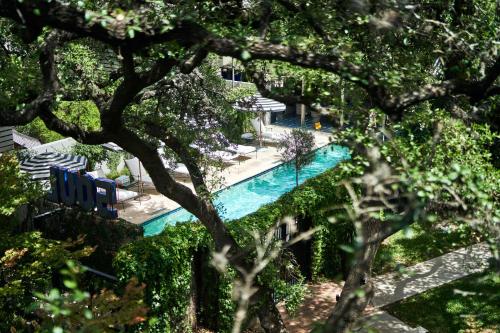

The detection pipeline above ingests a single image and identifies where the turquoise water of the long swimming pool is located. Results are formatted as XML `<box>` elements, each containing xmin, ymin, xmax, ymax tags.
<box><xmin>142</xmin><ymin>145</ymin><xmax>350</xmax><ymax>236</ymax></box>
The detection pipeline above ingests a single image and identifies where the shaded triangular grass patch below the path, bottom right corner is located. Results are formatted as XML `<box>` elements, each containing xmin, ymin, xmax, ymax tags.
<box><xmin>385</xmin><ymin>273</ymin><xmax>500</xmax><ymax>333</ymax></box>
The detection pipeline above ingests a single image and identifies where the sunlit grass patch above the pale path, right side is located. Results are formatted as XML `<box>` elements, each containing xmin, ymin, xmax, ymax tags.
<box><xmin>373</xmin><ymin>225</ymin><xmax>479</xmax><ymax>275</ymax></box>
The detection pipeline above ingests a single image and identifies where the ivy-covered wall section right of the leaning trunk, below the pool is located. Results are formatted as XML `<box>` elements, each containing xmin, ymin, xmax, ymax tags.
<box><xmin>231</xmin><ymin>164</ymin><xmax>356</xmax><ymax>280</ymax></box>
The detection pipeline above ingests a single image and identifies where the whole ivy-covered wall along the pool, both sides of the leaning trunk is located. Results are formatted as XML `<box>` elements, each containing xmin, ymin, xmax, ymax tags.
<box><xmin>113</xmin><ymin>162</ymin><xmax>354</xmax><ymax>333</ymax></box>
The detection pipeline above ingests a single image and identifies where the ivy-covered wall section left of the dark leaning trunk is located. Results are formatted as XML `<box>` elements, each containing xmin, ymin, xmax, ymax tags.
<box><xmin>113</xmin><ymin>223</ymin><xmax>234</xmax><ymax>333</ymax></box>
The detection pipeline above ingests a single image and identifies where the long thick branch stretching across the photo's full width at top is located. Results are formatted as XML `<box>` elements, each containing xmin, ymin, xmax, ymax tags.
<box><xmin>0</xmin><ymin>0</ymin><xmax>498</xmax><ymax>125</ymax></box>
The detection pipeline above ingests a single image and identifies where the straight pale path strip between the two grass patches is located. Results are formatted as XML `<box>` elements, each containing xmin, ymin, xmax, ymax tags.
<box><xmin>372</xmin><ymin>242</ymin><xmax>491</xmax><ymax>308</ymax></box>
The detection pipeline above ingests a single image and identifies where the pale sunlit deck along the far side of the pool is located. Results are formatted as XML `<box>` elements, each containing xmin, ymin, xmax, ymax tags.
<box><xmin>116</xmin><ymin>126</ymin><xmax>331</xmax><ymax>224</ymax></box>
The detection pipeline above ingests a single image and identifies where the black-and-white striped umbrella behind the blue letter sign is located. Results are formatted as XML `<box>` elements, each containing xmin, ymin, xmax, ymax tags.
<box><xmin>20</xmin><ymin>152</ymin><xmax>87</xmax><ymax>179</ymax></box>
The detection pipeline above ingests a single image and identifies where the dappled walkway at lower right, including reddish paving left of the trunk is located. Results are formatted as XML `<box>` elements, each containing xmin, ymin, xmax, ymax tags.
<box><xmin>280</xmin><ymin>243</ymin><xmax>491</xmax><ymax>333</ymax></box>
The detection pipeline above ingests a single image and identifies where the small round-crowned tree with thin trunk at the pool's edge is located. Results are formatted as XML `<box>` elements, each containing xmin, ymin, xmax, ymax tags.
<box><xmin>278</xmin><ymin>129</ymin><xmax>314</xmax><ymax>186</ymax></box>
